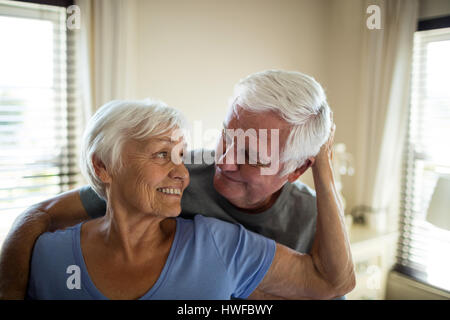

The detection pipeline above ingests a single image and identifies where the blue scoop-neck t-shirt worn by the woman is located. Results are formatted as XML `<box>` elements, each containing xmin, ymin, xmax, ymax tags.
<box><xmin>27</xmin><ymin>215</ymin><xmax>275</xmax><ymax>300</ymax></box>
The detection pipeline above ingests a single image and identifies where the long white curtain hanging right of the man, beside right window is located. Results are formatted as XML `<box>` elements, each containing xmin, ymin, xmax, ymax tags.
<box><xmin>355</xmin><ymin>0</ymin><xmax>418</xmax><ymax>231</ymax></box>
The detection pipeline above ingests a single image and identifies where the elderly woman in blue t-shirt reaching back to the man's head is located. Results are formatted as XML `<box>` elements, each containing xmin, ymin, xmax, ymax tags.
<box><xmin>28</xmin><ymin>101</ymin><xmax>354</xmax><ymax>299</ymax></box>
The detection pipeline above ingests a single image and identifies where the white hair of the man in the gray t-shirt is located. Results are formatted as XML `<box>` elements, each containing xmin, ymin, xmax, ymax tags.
<box><xmin>230</xmin><ymin>70</ymin><xmax>331</xmax><ymax>176</ymax></box>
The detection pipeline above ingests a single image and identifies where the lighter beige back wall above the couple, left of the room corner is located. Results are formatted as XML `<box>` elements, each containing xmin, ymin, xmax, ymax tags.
<box><xmin>138</xmin><ymin>0</ymin><xmax>328</xmax><ymax>146</ymax></box>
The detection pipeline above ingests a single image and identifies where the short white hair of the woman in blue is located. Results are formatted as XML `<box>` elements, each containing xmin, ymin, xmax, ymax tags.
<box><xmin>80</xmin><ymin>99</ymin><xmax>187</xmax><ymax>198</ymax></box>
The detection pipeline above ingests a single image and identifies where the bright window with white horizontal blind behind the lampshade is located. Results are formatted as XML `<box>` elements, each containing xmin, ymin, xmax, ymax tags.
<box><xmin>396</xmin><ymin>28</ymin><xmax>450</xmax><ymax>291</ymax></box>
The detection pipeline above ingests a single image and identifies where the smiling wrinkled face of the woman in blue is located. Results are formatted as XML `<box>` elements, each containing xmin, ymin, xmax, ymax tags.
<box><xmin>111</xmin><ymin>131</ymin><xmax>189</xmax><ymax>217</ymax></box>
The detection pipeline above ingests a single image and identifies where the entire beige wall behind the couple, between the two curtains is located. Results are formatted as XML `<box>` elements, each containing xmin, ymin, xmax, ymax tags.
<box><xmin>133</xmin><ymin>0</ymin><xmax>365</xmax><ymax>207</ymax></box>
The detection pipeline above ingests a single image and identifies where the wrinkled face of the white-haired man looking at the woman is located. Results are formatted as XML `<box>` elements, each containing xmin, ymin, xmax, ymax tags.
<box><xmin>214</xmin><ymin>106</ymin><xmax>289</xmax><ymax>212</ymax></box>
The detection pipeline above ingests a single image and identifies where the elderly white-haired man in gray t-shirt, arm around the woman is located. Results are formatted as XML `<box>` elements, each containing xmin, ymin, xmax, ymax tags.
<box><xmin>0</xmin><ymin>70</ymin><xmax>348</xmax><ymax>298</ymax></box>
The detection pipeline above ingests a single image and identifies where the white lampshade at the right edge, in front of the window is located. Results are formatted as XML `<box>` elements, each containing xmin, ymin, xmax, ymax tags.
<box><xmin>426</xmin><ymin>176</ymin><xmax>450</xmax><ymax>230</ymax></box>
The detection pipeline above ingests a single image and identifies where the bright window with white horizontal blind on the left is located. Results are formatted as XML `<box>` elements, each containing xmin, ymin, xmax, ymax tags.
<box><xmin>0</xmin><ymin>1</ymin><xmax>79</xmax><ymax>235</ymax></box>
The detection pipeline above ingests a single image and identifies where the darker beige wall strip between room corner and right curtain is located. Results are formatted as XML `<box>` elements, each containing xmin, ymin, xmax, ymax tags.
<box><xmin>284</xmin><ymin>0</ymin><xmax>367</xmax><ymax>211</ymax></box>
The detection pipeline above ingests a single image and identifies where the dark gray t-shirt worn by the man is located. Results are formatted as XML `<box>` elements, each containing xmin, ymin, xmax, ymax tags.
<box><xmin>80</xmin><ymin>151</ymin><xmax>317</xmax><ymax>253</ymax></box>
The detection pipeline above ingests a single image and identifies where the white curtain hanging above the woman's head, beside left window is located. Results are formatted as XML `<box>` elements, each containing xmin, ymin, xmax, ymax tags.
<box><xmin>75</xmin><ymin>0</ymin><xmax>138</xmax><ymax>118</ymax></box>
